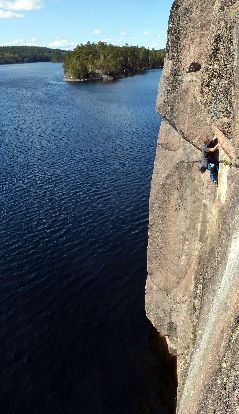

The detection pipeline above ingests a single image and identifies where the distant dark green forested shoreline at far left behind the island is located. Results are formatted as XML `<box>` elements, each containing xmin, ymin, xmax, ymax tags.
<box><xmin>0</xmin><ymin>46</ymin><xmax>67</xmax><ymax>65</ymax></box>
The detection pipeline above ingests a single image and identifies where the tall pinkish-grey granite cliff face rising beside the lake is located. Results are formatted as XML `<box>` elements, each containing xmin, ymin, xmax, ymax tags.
<box><xmin>146</xmin><ymin>0</ymin><xmax>239</xmax><ymax>414</ymax></box>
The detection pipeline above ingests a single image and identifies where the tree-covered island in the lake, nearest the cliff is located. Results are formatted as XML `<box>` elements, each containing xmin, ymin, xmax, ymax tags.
<box><xmin>64</xmin><ymin>42</ymin><xmax>165</xmax><ymax>82</ymax></box>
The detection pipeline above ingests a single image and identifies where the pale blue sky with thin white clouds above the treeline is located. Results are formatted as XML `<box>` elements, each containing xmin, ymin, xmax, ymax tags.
<box><xmin>0</xmin><ymin>0</ymin><xmax>173</xmax><ymax>49</ymax></box>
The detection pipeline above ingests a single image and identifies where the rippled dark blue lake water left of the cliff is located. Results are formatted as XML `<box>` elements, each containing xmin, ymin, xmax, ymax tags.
<box><xmin>0</xmin><ymin>63</ymin><xmax>161</xmax><ymax>414</ymax></box>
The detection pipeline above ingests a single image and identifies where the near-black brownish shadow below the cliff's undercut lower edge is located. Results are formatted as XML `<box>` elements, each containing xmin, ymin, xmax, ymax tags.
<box><xmin>138</xmin><ymin>322</ymin><xmax>178</xmax><ymax>414</ymax></box>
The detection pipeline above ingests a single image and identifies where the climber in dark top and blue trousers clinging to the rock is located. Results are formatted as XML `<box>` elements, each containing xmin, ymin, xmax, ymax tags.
<box><xmin>199</xmin><ymin>138</ymin><xmax>219</xmax><ymax>185</ymax></box>
